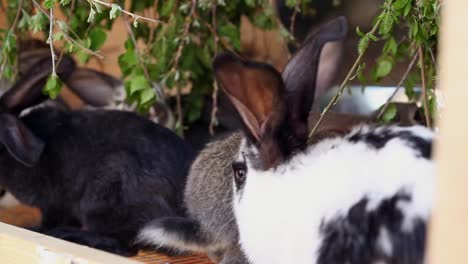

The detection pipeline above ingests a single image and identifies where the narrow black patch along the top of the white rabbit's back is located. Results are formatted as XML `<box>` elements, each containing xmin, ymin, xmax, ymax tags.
<box><xmin>348</xmin><ymin>128</ymin><xmax>432</xmax><ymax>159</ymax></box>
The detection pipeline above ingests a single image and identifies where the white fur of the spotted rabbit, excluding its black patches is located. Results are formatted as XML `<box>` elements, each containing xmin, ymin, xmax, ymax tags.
<box><xmin>234</xmin><ymin>127</ymin><xmax>435</xmax><ymax>264</ymax></box>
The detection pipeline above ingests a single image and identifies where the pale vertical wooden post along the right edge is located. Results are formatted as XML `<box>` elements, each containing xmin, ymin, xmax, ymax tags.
<box><xmin>428</xmin><ymin>0</ymin><xmax>468</xmax><ymax>264</ymax></box>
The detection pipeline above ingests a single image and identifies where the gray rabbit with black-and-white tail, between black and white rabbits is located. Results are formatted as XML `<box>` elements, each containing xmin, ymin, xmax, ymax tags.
<box><xmin>138</xmin><ymin>132</ymin><xmax>248</xmax><ymax>264</ymax></box>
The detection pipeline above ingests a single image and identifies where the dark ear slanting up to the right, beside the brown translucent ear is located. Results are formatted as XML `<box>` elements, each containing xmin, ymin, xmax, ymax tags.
<box><xmin>282</xmin><ymin>17</ymin><xmax>348</xmax><ymax>137</ymax></box>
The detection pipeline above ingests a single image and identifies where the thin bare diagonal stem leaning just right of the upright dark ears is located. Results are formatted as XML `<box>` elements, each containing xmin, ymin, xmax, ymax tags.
<box><xmin>307</xmin><ymin>20</ymin><xmax>380</xmax><ymax>144</ymax></box>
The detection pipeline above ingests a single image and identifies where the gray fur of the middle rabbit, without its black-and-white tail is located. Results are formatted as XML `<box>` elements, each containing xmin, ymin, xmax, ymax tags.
<box><xmin>184</xmin><ymin>132</ymin><xmax>248</xmax><ymax>264</ymax></box>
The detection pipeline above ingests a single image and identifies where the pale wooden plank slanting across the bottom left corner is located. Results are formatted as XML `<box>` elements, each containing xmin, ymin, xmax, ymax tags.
<box><xmin>0</xmin><ymin>223</ymin><xmax>140</xmax><ymax>264</ymax></box>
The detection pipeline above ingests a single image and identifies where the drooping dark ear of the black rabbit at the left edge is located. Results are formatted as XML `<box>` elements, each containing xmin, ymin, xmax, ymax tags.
<box><xmin>0</xmin><ymin>114</ymin><xmax>45</xmax><ymax>167</ymax></box>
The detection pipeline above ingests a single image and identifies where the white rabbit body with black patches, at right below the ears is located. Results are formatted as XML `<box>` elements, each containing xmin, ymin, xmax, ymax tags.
<box><xmin>234</xmin><ymin>126</ymin><xmax>435</xmax><ymax>264</ymax></box>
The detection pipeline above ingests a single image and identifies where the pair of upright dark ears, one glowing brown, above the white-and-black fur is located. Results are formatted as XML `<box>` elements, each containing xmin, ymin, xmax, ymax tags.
<box><xmin>213</xmin><ymin>17</ymin><xmax>347</xmax><ymax>169</ymax></box>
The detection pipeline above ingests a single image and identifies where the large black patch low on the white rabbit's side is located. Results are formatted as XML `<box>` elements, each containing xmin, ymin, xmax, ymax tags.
<box><xmin>317</xmin><ymin>192</ymin><xmax>426</xmax><ymax>264</ymax></box>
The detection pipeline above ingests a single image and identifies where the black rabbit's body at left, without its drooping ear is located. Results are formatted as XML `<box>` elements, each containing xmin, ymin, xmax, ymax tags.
<box><xmin>0</xmin><ymin>108</ymin><xmax>193</xmax><ymax>255</ymax></box>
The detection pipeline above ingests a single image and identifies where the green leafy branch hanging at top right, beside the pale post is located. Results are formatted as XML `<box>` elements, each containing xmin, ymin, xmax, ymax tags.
<box><xmin>309</xmin><ymin>0</ymin><xmax>440</xmax><ymax>142</ymax></box>
